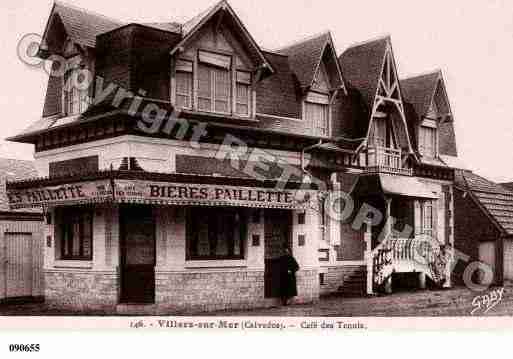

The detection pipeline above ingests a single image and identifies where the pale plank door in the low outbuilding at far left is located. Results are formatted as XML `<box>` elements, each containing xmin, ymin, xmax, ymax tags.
<box><xmin>4</xmin><ymin>233</ymin><xmax>32</xmax><ymax>298</ymax></box>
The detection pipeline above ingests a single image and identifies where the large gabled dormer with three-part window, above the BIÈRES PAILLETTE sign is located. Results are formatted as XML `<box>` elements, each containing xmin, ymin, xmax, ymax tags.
<box><xmin>171</xmin><ymin>1</ymin><xmax>273</xmax><ymax>118</ymax></box>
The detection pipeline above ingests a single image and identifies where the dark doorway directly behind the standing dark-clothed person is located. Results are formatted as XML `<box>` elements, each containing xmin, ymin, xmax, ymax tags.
<box><xmin>264</xmin><ymin>209</ymin><xmax>292</xmax><ymax>298</ymax></box>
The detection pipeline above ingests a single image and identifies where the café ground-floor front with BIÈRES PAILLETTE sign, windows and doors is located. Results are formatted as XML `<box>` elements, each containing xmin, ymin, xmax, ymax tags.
<box><xmin>8</xmin><ymin>171</ymin><xmax>319</xmax><ymax>310</ymax></box>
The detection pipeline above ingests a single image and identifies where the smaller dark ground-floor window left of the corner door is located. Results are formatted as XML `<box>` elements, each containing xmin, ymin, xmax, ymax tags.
<box><xmin>57</xmin><ymin>209</ymin><xmax>93</xmax><ymax>260</ymax></box>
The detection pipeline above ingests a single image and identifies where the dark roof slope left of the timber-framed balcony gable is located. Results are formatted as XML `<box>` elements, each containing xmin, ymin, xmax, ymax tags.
<box><xmin>339</xmin><ymin>36</ymin><xmax>390</xmax><ymax>110</ymax></box>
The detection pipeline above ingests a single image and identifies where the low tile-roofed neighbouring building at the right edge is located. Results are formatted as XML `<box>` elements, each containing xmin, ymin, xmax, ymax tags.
<box><xmin>454</xmin><ymin>171</ymin><xmax>513</xmax><ymax>285</ymax></box>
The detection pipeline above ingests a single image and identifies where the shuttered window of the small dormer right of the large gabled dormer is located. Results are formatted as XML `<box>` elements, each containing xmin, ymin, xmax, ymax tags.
<box><xmin>304</xmin><ymin>92</ymin><xmax>330</xmax><ymax>136</ymax></box>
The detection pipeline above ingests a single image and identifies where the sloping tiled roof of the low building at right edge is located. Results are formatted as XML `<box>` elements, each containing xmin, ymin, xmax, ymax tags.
<box><xmin>455</xmin><ymin>171</ymin><xmax>513</xmax><ymax>235</ymax></box>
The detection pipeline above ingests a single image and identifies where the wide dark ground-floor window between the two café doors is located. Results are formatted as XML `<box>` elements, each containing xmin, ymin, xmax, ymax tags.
<box><xmin>186</xmin><ymin>207</ymin><xmax>247</xmax><ymax>260</ymax></box>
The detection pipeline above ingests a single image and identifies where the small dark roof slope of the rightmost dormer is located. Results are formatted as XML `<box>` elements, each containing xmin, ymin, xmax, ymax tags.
<box><xmin>400</xmin><ymin>70</ymin><xmax>440</xmax><ymax>120</ymax></box>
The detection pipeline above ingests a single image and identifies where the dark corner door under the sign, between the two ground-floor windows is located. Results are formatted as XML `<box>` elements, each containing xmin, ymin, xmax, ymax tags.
<box><xmin>120</xmin><ymin>206</ymin><xmax>156</xmax><ymax>303</ymax></box>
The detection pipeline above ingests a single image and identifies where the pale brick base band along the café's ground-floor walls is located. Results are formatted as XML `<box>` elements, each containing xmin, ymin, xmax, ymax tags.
<box><xmin>45</xmin><ymin>269</ymin><xmax>319</xmax><ymax>314</ymax></box>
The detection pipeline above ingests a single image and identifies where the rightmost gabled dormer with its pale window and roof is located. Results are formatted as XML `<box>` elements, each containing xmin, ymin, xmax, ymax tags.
<box><xmin>401</xmin><ymin>70</ymin><xmax>453</xmax><ymax>160</ymax></box>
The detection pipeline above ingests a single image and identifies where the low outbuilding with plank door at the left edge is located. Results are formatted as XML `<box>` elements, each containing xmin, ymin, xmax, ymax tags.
<box><xmin>0</xmin><ymin>158</ymin><xmax>44</xmax><ymax>303</ymax></box>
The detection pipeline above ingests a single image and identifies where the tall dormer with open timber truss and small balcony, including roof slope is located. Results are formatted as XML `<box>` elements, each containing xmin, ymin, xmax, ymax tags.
<box><xmin>340</xmin><ymin>36</ymin><xmax>413</xmax><ymax>174</ymax></box>
